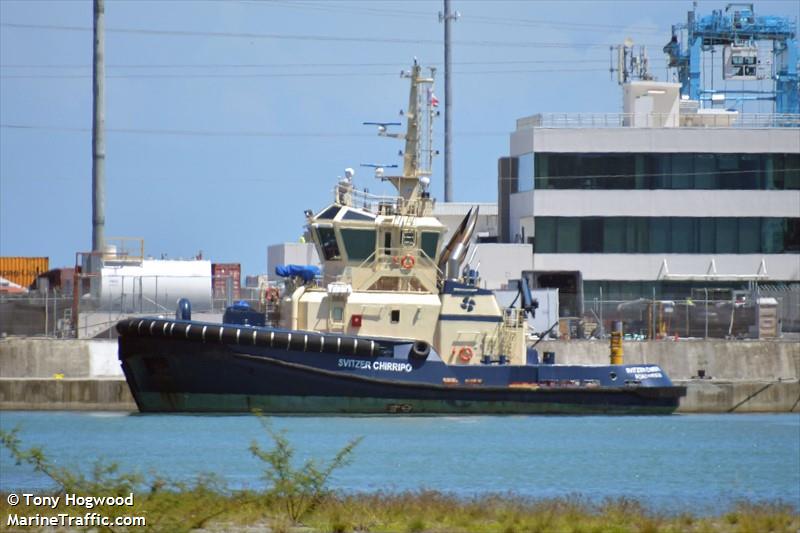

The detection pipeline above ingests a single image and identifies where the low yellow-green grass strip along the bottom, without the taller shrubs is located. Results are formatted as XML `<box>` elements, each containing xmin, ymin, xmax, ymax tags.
<box><xmin>0</xmin><ymin>485</ymin><xmax>800</xmax><ymax>533</ymax></box>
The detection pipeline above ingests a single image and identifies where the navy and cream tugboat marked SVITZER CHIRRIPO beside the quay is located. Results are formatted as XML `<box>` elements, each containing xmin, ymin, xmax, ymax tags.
<box><xmin>117</xmin><ymin>62</ymin><xmax>686</xmax><ymax>414</ymax></box>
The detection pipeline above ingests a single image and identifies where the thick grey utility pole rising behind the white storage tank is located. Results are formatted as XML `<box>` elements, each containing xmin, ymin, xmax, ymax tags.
<box><xmin>90</xmin><ymin>0</ymin><xmax>106</xmax><ymax>260</ymax></box>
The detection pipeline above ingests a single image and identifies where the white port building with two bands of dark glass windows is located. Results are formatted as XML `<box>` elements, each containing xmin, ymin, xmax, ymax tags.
<box><xmin>498</xmin><ymin>81</ymin><xmax>800</xmax><ymax>313</ymax></box>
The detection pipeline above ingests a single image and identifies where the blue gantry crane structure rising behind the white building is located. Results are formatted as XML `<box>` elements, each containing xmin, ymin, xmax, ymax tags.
<box><xmin>664</xmin><ymin>3</ymin><xmax>800</xmax><ymax>114</ymax></box>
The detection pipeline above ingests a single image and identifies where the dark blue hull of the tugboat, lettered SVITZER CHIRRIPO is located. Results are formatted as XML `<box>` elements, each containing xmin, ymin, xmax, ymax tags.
<box><xmin>118</xmin><ymin>319</ymin><xmax>685</xmax><ymax>414</ymax></box>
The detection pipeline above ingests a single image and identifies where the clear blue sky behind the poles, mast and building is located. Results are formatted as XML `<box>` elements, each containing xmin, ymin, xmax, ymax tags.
<box><xmin>0</xmin><ymin>0</ymin><xmax>800</xmax><ymax>274</ymax></box>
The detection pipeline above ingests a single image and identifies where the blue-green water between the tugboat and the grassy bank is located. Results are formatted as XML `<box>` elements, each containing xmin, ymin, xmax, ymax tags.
<box><xmin>0</xmin><ymin>412</ymin><xmax>800</xmax><ymax>514</ymax></box>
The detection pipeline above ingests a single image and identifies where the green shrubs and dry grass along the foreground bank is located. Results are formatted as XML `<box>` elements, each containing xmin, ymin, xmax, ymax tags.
<box><xmin>0</xmin><ymin>417</ymin><xmax>800</xmax><ymax>533</ymax></box>
